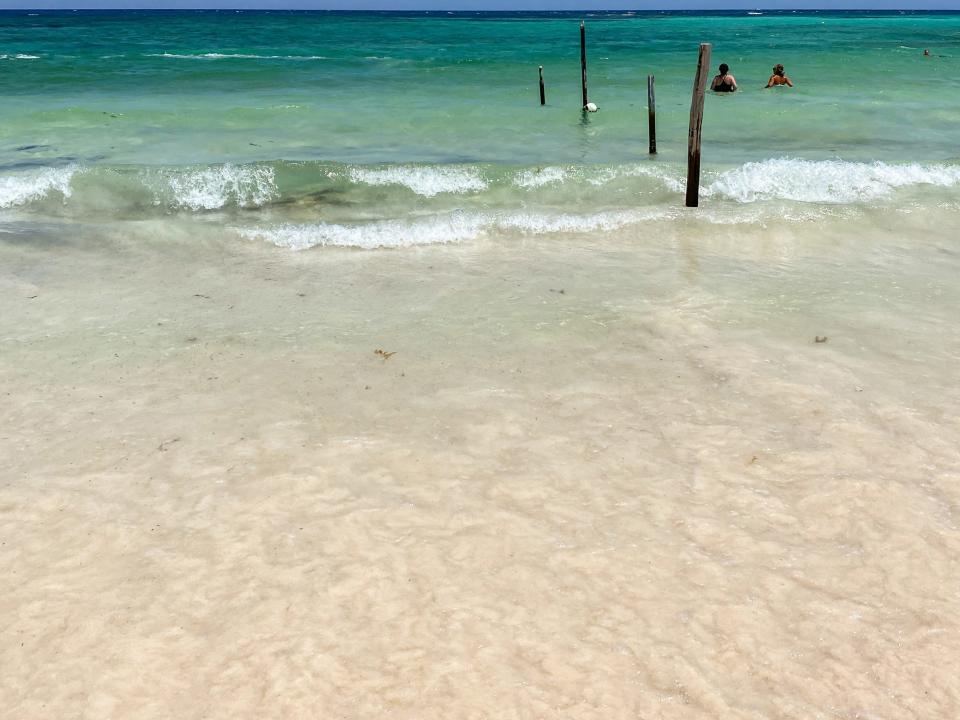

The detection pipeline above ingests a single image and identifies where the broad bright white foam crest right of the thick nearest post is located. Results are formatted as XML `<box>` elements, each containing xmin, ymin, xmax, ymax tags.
<box><xmin>704</xmin><ymin>158</ymin><xmax>960</xmax><ymax>204</ymax></box>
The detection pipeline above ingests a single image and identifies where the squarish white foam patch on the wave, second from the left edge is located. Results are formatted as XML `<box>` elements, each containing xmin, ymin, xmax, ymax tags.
<box><xmin>154</xmin><ymin>165</ymin><xmax>279</xmax><ymax>210</ymax></box>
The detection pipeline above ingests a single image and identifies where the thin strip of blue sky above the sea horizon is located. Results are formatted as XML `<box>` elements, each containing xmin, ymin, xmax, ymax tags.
<box><xmin>0</xmin><ymin>0</ymin><xmax>960</xmax><ymax>10</ymax></box>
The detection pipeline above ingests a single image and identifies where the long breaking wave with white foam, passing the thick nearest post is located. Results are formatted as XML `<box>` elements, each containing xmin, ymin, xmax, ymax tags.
<box><xmin>0</xmin><ymin>158</ymin><xmax>960</xmax><ymax>229</ymax></box>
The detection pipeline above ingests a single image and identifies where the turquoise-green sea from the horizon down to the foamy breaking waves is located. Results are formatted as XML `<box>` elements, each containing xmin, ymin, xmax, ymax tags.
<box><xmin>0</xmin><ymin>11</ymin><xmax>960</xmax><ymax>246</ymax></box>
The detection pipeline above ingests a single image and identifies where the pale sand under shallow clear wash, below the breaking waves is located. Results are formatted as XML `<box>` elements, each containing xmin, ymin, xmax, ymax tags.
<box><xmin>0</xmin><ymin>211</ymin><xmax>960</xmax><ymax>720</ymax></box>
